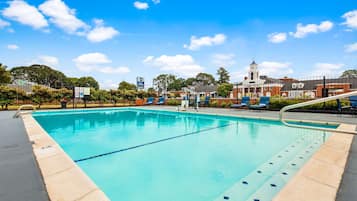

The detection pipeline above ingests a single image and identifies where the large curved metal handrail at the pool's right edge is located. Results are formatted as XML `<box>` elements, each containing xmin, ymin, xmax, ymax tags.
<box><xmin>279</xmin><ymin>91</ymin><xmax>357</xmax><ymax>135</ymax></box>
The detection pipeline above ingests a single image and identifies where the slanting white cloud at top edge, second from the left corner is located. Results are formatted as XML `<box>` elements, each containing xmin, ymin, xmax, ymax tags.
<box><xmin>39</xmin><ymin>0</ymin><xmax>88</xmax><ymax>35</ymax></box>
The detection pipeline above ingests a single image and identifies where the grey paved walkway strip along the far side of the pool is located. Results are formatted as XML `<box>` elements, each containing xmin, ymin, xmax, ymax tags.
<box><xmin>144</xmin><ymin>106</ymin><xmax>357</xmax><ymax>124</ymax></box>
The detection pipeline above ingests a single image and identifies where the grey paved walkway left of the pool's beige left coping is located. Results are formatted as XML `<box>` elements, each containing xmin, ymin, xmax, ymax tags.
<box><xmin>0</xmin><ymin>111</ymin><xmax>49</xmax><ymax>201</ymax></box>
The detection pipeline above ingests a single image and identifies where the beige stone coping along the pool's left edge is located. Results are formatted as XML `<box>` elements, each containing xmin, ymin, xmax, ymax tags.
<box><xmin>21</xmin><ymin>114</ymin><xmax>110</xmax><ymax>201</ymax></box>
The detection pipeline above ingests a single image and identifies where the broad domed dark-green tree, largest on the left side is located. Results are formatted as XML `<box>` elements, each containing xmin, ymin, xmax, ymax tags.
<box><xmin>10</xmin><ymin>64</ymin><xmax>66</xmax><ymax>89</ymax></box>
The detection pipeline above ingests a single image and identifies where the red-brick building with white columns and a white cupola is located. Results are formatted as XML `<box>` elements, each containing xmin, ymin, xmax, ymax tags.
<box><xmin>231</xmin><ymin>61</ymin><xmax>284</xmax><ymax>98</ymax></box>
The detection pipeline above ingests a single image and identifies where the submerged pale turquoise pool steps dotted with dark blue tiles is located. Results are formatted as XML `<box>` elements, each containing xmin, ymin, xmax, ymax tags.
<box><xmin>215</xmin><ymin>134</ymin><xmax>322</xmax><ymax>201</ymax></box>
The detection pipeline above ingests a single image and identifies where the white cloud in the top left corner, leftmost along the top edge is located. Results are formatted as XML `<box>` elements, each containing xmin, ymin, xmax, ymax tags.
<box><xmin>2</xmin><ymin>0</ymin><xmax>48</xmax><ymax>29</ymax></box>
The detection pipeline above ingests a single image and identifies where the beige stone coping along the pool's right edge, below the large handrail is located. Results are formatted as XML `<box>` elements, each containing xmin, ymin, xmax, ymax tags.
<box><xmin>273</xmin><ymin>124</ymin><xmax>357</xmax><ymax>201</ymax></box>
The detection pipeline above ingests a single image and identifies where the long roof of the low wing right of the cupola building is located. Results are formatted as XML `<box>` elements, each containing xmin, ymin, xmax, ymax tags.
<box><xmin>281</xmin><ymin>78</ymin><xmax>357</xmax><ymax>91</ymax></box>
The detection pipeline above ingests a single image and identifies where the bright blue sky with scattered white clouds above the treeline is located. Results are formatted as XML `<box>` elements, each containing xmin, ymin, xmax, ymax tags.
<box><xmin>0</xmin><ymin>0</ymin><xmax>357</xmax><ymax>88</ymax></box>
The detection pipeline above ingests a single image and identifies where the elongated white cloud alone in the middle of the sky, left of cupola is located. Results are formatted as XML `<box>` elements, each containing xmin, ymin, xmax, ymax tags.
<box><xmin>184</xmin><ymin>34</ymin><xmax>227</xmax><ymax>50</ymax></box>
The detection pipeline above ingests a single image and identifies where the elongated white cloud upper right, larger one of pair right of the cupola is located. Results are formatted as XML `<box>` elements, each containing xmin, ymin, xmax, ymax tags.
<box><xmin>290</xmin><ymin>21</ymin><xmax>333</xmax><ymax>38</ymax></box>
